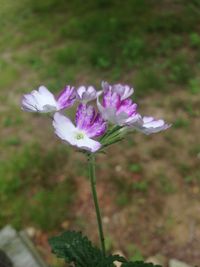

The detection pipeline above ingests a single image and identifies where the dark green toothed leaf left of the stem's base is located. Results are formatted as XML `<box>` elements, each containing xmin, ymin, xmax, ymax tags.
<box><xmin>49</xmin><ymin>231</ymin><xmax>125</xmax><ymax>267</ymax></box>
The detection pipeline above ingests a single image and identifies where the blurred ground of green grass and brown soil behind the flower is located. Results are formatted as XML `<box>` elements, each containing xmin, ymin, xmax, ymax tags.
<box><xmin>0</xmin><ymin>0</ymin><xmax>200</xmax><ymax>266</ymax></box>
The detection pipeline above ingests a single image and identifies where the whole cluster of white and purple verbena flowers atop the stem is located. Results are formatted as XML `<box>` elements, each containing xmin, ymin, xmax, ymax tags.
<box><xmin>21</xmin><ymin>82</ymin><xmax>170</xmax><ymax>152</ymax></box>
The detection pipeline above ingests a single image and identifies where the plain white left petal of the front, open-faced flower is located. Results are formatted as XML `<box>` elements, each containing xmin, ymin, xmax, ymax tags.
<box><xmin>53</xmin><ymin>112</ymin><xmax>76</xmax><ymax>145</ymax></box>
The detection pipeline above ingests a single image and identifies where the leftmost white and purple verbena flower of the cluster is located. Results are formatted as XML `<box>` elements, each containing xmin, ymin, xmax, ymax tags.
<box><xmin>21</xmin><ymin>85</ymin><xmax>76</xmax><ymax>113</ymax></box>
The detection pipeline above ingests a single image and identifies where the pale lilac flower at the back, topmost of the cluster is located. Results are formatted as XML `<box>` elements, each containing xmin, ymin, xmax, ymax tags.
<box><xmin>101</xmin><ymin>82</ymin><xmax>134</xmax><ymax>100</ymax></box>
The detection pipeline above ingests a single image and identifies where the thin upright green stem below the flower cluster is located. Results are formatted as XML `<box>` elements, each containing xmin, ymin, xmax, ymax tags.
<box><xmin>88</xmin><ymin>154</ymin><xmax>106</xmax><ymax>256</ymax></box>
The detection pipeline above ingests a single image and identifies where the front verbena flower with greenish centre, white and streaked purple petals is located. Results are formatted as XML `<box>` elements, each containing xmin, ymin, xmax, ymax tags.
<box><xmin>53</xmin><ymin>104</ymin><xmax>107</xmax><ymax>152</ymax></box>
